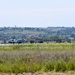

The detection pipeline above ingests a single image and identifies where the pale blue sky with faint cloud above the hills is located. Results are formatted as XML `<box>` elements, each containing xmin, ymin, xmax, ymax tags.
<box><xmin>0</xmin><ymin>0</ymin><xmax>75</xmax><ymax>27</ymax></box>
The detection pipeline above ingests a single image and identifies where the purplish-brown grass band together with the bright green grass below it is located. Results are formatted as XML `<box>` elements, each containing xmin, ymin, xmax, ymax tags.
<box><xmin>0</xmin><ymin>50</ymin><xmax>75</xmax><ymax>73</ymax></box>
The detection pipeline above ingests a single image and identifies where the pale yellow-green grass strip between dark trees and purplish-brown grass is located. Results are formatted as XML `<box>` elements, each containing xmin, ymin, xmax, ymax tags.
<box><xmin>0</xmin><ymin>43</ymin><xmax>75</xmax><ymax>50</ymax></box>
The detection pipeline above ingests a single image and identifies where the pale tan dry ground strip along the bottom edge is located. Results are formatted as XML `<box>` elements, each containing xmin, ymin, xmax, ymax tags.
<box><xmin>0</xmin><ymin>71</ymin><xmax>75</xmax><ymax>75</ymax></box>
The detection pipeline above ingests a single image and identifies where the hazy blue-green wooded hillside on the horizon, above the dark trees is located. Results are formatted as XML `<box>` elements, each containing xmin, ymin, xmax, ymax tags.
<box><xmin>0</xmin><ymin>27</ymin><xmax>75</xmax><ymax>41</ymax></box>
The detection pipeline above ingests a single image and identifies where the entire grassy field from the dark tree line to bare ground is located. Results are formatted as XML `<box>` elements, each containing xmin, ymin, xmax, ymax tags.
<box><xmin>0</xmin><ymin>43</ymin><xmax>75</xmax><ymax>75</ymax></box>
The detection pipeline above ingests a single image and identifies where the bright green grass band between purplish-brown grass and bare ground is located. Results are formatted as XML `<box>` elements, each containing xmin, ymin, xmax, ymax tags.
<box><xmin>0</xmin><ymin>60</ymin><xmax>75</xmax><ymax>73</ymax></box>
